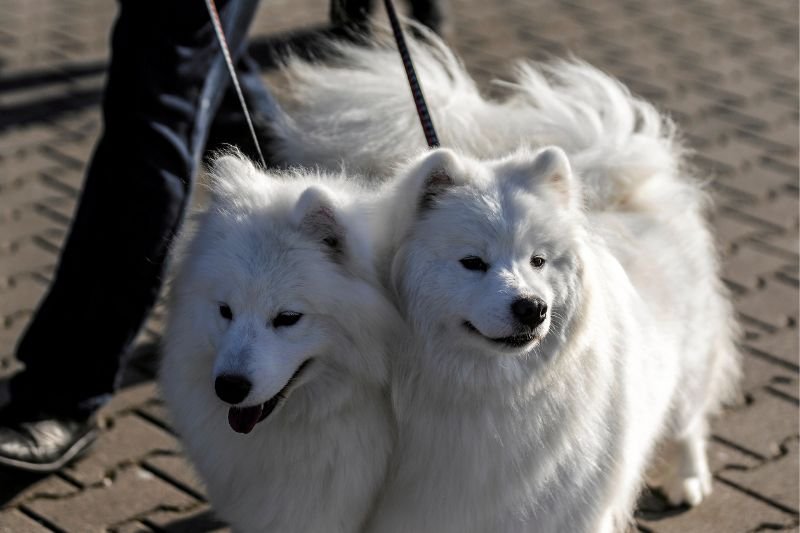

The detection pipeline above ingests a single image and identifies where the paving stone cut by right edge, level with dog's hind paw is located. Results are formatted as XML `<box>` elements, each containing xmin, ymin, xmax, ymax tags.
<box><xmin>719</xmin><ymin>438</ymin><xmax>800</xmax><ymax>513</ymax></box>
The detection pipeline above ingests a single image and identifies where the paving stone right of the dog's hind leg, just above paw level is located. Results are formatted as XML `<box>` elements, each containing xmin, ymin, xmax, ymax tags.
<box><xmin>712</xmin><ymin>391</ymin><xmax>799</xmax><ymax>459</ymax></box>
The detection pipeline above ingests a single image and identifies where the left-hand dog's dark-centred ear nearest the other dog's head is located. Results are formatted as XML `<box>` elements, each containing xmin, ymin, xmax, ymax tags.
<box><xmin>292</xmin><ymin>186</ymin><xmax>345</xmax><ymax>253</ymax></box>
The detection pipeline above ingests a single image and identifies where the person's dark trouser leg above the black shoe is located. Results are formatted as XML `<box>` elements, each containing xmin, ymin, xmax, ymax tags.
<box><xmin>10</xmin><ymin>0</ymin><xmax>271</xmax><ymax>413</ymax></box>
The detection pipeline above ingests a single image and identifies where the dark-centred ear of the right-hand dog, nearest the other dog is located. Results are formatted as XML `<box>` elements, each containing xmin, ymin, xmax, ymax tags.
<box><xmin>409</xmin><ymin>148</ymin><xmax>461</xmax><ymax>211</ymax></box>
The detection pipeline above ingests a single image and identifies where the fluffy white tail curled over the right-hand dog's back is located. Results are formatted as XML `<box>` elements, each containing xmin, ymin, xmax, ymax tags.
<box><xmin>504</xmin><ymin>60</ymin><xmax>698</xmax><ymax>211</ymax></box>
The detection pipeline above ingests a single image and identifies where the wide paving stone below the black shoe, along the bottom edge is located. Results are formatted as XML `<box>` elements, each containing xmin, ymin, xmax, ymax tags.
<box><xmin>26</xmin><ymin>466</ymin><xmax>196</xmax><ymax>533</ymax></box>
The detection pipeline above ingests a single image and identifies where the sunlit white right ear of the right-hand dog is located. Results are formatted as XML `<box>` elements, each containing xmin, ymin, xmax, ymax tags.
<box><xmin>516</xmin><ymin>146</ymin><xmax>580</xmax><ymax>208</ymax></box>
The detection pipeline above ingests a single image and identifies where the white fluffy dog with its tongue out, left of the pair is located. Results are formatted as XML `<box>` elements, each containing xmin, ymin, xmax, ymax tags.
<box><xmin>161</xmin><ymin>156</ymin><xmax>402</xmax><ymax>533</ymax></box>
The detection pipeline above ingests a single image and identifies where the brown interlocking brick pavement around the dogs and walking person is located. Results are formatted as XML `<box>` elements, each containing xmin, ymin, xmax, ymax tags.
<box><xmin>0</xmin><ymin>0</ymin><xmax>800</xmax><ymax>533</ymax></box>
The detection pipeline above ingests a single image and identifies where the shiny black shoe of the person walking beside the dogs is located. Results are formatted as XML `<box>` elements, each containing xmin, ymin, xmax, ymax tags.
<box><xmin>0</xmin><ymin>405</ymin><xmax>98</xmax><ymax>473</ymax></box>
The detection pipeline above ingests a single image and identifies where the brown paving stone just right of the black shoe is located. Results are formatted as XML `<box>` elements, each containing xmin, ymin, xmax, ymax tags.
<box><xmin>64</xmin><ymin>414</ymin><xmax>180</xmax><ymax>486</ymax></box>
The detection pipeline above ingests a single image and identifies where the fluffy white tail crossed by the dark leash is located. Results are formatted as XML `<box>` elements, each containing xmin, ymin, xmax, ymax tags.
<box><xmin>272</xmin><ymin>28</ymin><xmax>494</xmax><ymax>178</ymax></box>
